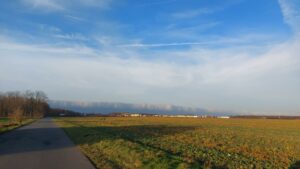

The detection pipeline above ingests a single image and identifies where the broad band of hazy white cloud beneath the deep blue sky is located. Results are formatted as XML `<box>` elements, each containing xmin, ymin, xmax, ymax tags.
<box><xmin>0</xmin><ymin>32</ymin><xmax>300</xmax><ymax>114</ymax></box>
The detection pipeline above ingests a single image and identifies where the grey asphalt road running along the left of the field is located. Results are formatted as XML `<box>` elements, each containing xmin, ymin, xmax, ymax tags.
<box><xmin>0</xmin><ymin>118</ymin><xmax>94</xmax><ymax>169</ymax></box>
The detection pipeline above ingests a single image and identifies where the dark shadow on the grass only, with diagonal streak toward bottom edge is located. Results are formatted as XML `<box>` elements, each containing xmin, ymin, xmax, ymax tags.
<box><xmin>64</xmin><ymin>125</ymin><xmax>226</xmax><ymax>169</ymax></box>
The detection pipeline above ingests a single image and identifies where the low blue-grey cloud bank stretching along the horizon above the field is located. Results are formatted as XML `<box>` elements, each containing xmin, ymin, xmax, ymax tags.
<box><xmin>48</xmin><ymin>100</ymin><xmax>299</xmax><ymax>116</ymax></box>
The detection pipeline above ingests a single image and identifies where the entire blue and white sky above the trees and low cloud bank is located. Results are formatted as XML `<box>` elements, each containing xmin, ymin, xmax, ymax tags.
<box><xmin>0</xmin><ymin>0</ymin><xmax>300</xmax><ymax>115</ymax></box>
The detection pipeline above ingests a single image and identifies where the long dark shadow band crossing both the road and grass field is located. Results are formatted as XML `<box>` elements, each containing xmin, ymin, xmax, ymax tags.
<box><xmin>0</xmin><ymin>121</ymin><xmax>194</xmax><ymax>158</ymax></box>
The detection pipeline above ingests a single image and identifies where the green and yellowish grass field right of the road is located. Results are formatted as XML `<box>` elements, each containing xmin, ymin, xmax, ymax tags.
<box><xmin>56</xmin><ymin>117</ymin><xmax>300</xmax><ymax>169</ymax></box>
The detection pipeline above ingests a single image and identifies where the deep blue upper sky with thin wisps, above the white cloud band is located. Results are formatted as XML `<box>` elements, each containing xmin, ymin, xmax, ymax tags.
<box><xmin>0</xmin><ymin>0</ymin><xmax>291</xmax><ymax>47</ymax></box>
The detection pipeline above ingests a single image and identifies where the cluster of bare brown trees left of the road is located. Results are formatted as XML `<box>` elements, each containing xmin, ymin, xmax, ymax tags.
<box><xmin>0</xmin><ymin>90</ymin><xmax>50</xmax><ymax>118</ymax></box>
